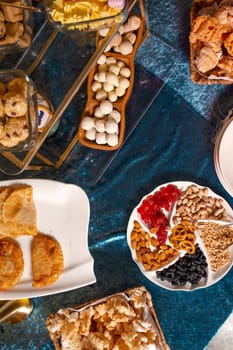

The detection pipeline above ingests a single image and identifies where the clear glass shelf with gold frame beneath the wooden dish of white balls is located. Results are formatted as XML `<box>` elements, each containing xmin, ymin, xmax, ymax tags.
<box><xmin>0</xmin><ymin>0</ymin><xmax>176</xmax><ymax>185</ymax></box>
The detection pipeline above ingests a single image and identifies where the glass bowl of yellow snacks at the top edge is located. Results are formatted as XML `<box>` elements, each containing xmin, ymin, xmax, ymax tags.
<box><xmin>46</xmin><ymin>0</ymin><xmax>128</xmax><ymax>32</ymax></box>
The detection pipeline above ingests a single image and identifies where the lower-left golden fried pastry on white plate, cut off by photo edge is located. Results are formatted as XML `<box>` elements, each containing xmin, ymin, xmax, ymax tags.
<box><xmin>0</xmin><ymin>238</ymin><xmax>24</xmax><ymax>290</ymax></box>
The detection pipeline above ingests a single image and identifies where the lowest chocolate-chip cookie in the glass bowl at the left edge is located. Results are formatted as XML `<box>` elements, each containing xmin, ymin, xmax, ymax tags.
<box><xmin>0</xmin><ymin>117</ymin><xmax>29</xmax><ymax>147</ymax></box>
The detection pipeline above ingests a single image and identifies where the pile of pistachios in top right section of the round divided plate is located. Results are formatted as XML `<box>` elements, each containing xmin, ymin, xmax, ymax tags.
<box><xmin>173</xmin><ymin>185</ymin><xmax>226</xmax><ymax>224</ymax></box>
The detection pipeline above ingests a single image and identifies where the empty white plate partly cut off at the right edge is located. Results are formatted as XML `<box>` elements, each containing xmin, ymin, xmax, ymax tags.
<box><xmin>214</xmin><ymin>118</ymin><xmax>233</xmax><ymax>196</ymax></box>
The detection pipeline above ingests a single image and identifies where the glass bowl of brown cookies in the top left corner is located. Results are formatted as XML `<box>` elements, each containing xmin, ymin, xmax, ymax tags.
<box><xmin>0</xmin><ymin>0</ymin><xmax>33</xmax><ymax>54</ymax></box>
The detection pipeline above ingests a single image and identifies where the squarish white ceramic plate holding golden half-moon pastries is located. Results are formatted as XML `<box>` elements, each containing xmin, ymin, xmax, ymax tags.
<box><xmin>0</xmin><ymin>179</ymin><xmax>96</xmax><ymax>300</ymax></box>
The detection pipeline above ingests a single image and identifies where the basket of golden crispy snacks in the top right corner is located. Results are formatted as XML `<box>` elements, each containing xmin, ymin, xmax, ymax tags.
<box><xmin>189</xmin><ymin>0</ymin><xmax>233</xmax><ymax>84</ymax></box>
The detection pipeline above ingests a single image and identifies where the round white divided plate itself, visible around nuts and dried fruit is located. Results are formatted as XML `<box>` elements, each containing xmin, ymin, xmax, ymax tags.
<box><xmin>127</xmin><ymin>181</ymin><xmax>233</xmax><ymax>291</ymax></box>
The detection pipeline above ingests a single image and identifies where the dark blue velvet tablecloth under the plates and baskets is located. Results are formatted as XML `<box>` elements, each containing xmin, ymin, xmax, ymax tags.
<box><xmin>0</xmin><ymin>0</ymin><xmax>233</xmax><ymax>350</ymax></box>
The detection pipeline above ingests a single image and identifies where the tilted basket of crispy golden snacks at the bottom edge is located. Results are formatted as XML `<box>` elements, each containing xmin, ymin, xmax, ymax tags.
<box><xmin>46</xmin><ymin>287</ymin><xmax>169</xmax><ymax>350</ymax></box>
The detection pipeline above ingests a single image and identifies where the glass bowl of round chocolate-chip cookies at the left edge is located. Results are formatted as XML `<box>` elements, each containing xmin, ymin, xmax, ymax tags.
<box><xmin>0</xmin><ymin>69</ymin><xmax>38</xmax><ymax>152</ymax></box>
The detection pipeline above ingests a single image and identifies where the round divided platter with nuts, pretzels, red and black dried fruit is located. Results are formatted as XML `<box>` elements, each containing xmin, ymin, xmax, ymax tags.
<box><xmin>127</xmin><ymin>181</ymin><xmax>233</xmax><ymax>291</ymax></box>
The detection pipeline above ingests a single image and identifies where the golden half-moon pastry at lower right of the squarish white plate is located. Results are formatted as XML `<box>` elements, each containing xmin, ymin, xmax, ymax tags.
<box><xmin>32</xmin><ymin>233</ymin><xmax>64</xmax><ymax>288</ymax></box>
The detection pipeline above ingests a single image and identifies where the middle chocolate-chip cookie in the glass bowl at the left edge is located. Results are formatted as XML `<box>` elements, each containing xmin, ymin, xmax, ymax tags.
<box><xmin>4</xmin><ymin>92</ymin><xmax>27</xmax><ymax>117</ymax></box>
